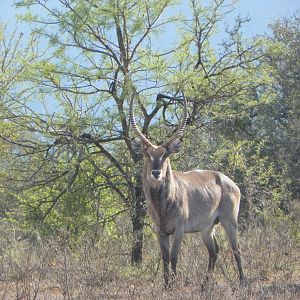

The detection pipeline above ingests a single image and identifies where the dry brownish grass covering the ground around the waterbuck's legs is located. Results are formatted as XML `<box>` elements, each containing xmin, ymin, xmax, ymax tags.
<box><xmin>0</xmin><ymin>219</ymin><xmax>300</xmax><ymax>300</ymax></box>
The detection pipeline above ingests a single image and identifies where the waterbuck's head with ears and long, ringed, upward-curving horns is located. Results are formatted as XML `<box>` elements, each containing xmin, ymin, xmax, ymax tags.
<box><xmin>129</xmin><ymin>98</ymin><xmax>187</xmax><ymax>181</ymax></box>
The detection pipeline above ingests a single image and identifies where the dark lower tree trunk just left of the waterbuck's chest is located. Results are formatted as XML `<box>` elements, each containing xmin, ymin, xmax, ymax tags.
<box><xmin>131</xmin><ymin>176</ymin><xmax>146</xmax><ymax>265</ymax></box>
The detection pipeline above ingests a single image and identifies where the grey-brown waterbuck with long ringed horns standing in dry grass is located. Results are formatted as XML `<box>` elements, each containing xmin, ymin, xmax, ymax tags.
<box><xmin>129</xmin><ymin>98</ymin><xmax>244</xmax><ymax>286</ymax></box>
